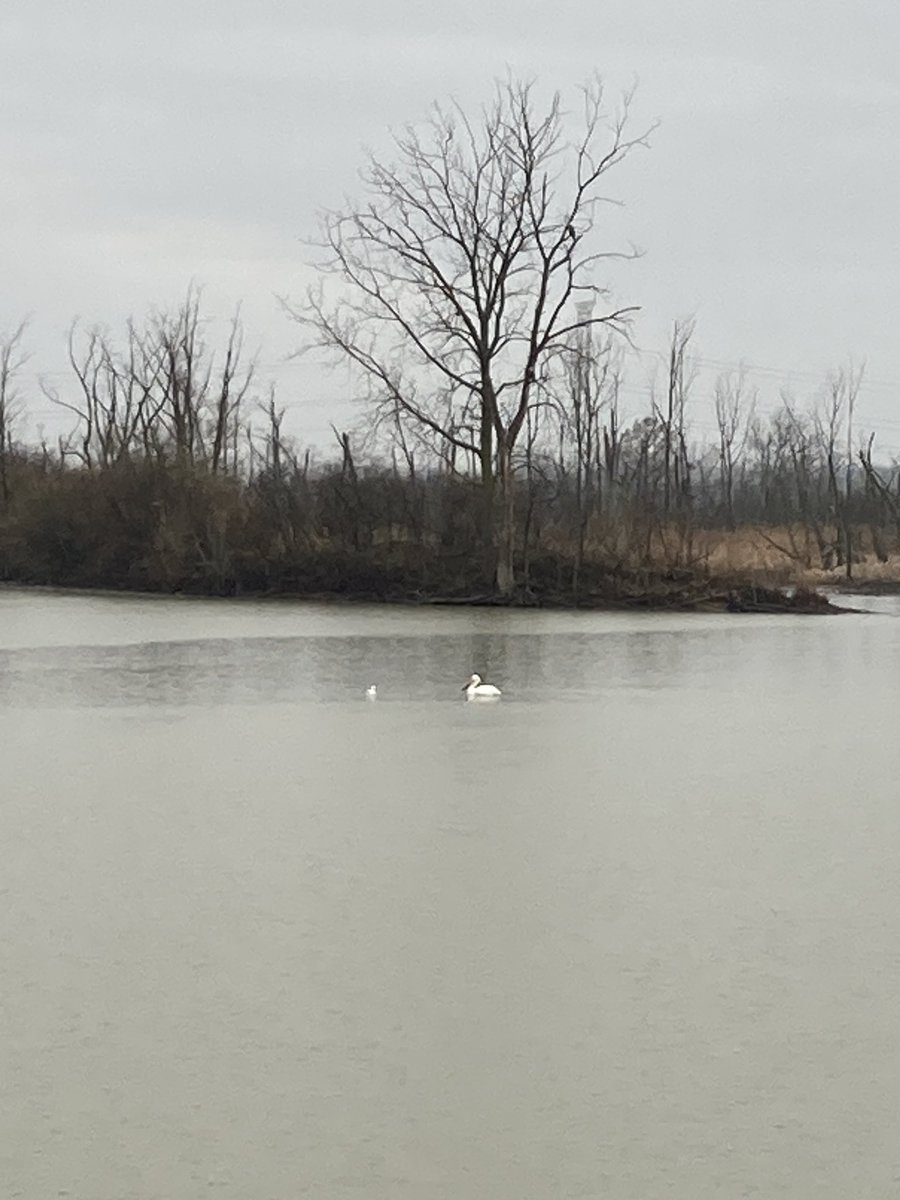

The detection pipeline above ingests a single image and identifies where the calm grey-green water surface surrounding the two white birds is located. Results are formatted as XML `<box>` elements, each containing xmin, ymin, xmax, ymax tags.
<box><xmin>0</xmin><ymin>592</ymin><xmax>900</xmax><ymax>1200</ymax></box>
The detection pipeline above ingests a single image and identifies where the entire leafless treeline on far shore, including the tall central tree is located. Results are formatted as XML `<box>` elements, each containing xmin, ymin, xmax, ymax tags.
<box><xmin>0</xmin><ymin>84</ymin><xmax>900</xmax><ymax>602</ymax></box>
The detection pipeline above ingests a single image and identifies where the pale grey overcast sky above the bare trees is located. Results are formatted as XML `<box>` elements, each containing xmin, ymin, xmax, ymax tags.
<box><xmin>0</xmin><ymin>0</ymin><xmax>900</xmax><ymax>454</ymax></box>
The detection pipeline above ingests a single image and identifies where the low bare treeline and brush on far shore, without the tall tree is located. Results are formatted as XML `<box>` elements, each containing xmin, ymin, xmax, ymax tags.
<box><xmin>0</xmin><ymin>300</ymin><xmax>900</xmax><ymax>601</ymax></box>
